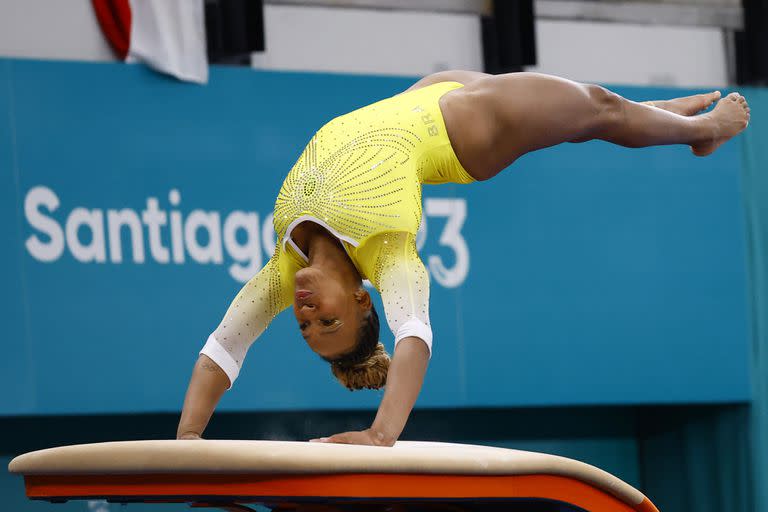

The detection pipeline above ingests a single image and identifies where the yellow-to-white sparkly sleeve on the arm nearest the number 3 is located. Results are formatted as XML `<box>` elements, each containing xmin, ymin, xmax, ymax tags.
<box><xmin>371</xmin><ymin>232</ymin><xmax>432</xmax><ymax>356</ymax></box>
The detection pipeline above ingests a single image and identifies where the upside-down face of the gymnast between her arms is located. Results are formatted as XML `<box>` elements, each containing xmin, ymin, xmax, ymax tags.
<box><xmin>293</xmin><ymin>267</ymin><xmax>365</xmax><ymax>359</ymax></box>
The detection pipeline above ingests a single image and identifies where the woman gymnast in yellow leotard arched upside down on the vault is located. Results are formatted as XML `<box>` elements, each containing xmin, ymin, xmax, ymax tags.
<box><xmin>177</xmin><ymin>71</ymin><xmax>749</xmax><ymax>446</ymax></box>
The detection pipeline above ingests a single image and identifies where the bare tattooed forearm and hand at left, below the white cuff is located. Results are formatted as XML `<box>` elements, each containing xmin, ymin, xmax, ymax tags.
<box><xmin>176</xmin><ymin>354</ymin><xmax>230</xmax><ymax>439</ymax></box>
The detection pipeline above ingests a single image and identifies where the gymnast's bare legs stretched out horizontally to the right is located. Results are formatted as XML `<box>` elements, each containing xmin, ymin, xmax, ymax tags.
<box><xmin>440</xmin><ymin>73</ymin><xmax>749</xmax><ymax>179</ymax></box>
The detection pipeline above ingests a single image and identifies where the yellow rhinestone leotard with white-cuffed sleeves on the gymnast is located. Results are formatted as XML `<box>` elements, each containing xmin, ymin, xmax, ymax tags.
<box><xmin>201</xmin><ymin>82</ymin><xmax>474</xmax><ymax>382</ymax></box>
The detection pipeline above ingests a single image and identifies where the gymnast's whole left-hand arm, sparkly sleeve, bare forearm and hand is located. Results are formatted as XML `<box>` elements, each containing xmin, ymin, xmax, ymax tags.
<box><xmin>176</xmin><ymin>254</ymin><xmax>290</xmax><ymax>439</ymax></box>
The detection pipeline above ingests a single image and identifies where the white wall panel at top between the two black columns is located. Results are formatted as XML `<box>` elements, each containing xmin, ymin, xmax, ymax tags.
<box><xmin>253</xmin><ymin>5</ymin><xmax>483</xmax><ymax>75</ymax></box>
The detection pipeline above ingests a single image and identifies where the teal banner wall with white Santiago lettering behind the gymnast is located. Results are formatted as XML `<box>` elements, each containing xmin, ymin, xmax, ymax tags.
<box><xmin>0</xmin><ymin>60</ymin><xmax>752</xmax><ymax>415</ymax></box>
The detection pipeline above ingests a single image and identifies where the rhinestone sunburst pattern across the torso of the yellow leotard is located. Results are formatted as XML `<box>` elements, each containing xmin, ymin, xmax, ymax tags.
<box><xmin>274</xmin><ymin>128</ymin><xmax>421</xmax><ymax>241</ymax></box>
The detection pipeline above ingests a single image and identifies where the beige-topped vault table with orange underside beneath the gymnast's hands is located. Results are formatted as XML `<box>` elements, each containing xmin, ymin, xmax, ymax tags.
<box><xmin>9</xmin><ymin>440</ymin><xmax>658</xmax><ymax>512</ymax></box>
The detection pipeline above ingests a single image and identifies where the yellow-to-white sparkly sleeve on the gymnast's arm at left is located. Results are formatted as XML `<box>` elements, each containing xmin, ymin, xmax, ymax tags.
<box><xmin>200</xmin><ymin>250</ymin><xmax>291</xmax><ymax>388</ymax></box>
